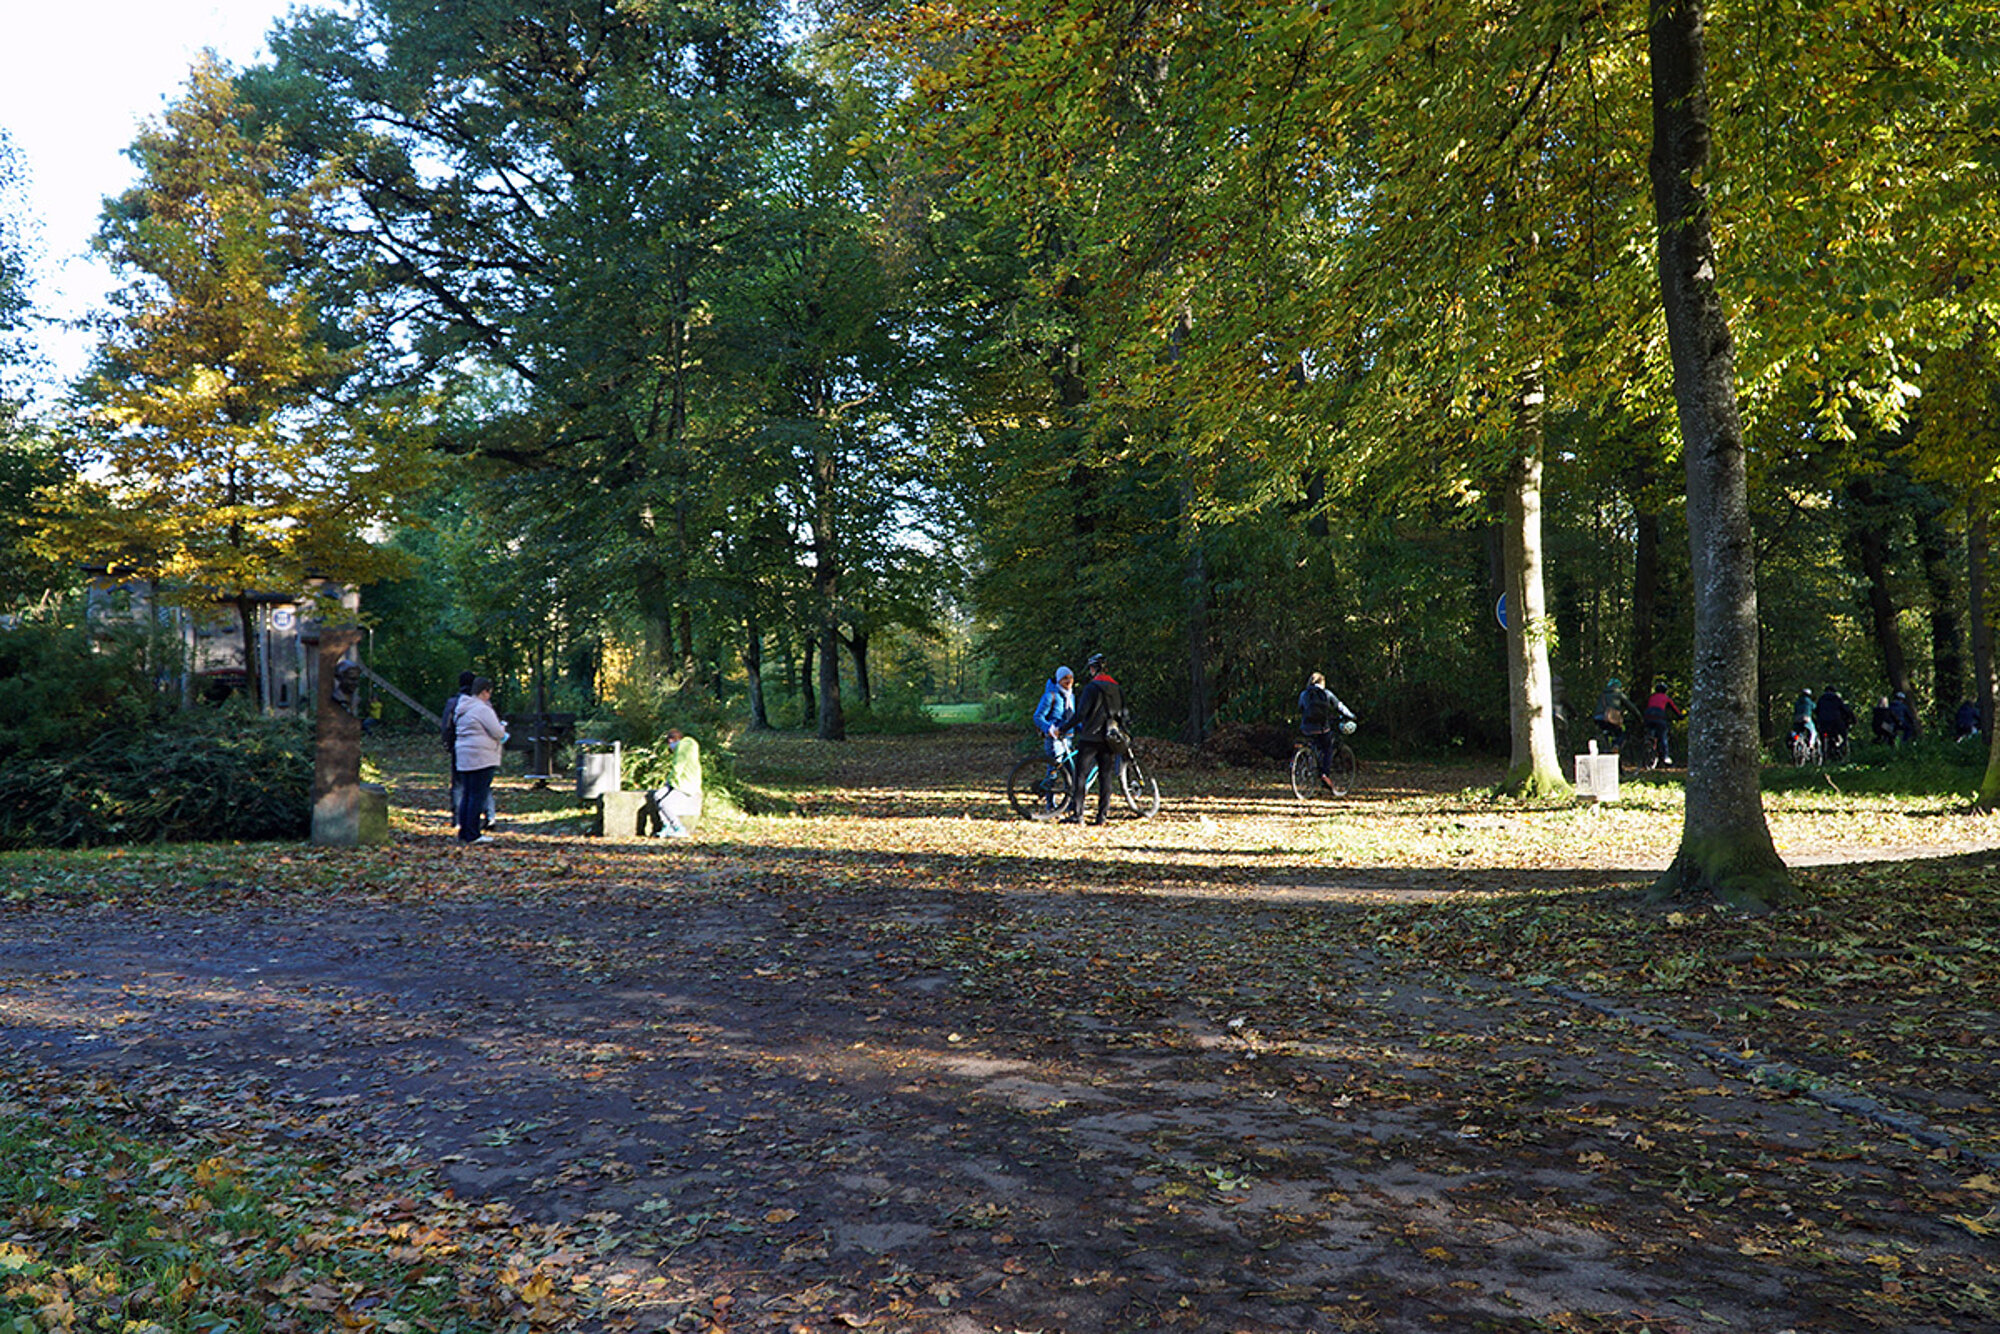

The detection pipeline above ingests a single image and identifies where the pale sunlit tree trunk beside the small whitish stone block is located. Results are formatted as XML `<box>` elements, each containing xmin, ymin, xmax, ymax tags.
<box><xmin>1502</xmin><ymin>372</ymin><xmax>1570</xmax><ymax>798</ymax></box>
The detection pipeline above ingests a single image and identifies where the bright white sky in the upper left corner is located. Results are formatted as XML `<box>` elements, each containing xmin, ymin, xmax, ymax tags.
<box><xmin>0</xmin><ymin>0</ymin><xmax>292</xmax><ymax>396</ymax></box>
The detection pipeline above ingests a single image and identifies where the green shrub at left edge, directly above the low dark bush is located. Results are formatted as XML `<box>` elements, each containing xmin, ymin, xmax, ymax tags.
<box><xmin>0</xmin><ymin>616</ymin><xmax>160</xmax><ymax>764</ymax></box>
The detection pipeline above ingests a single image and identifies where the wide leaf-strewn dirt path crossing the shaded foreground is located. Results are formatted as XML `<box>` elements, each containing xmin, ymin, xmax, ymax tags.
<box><xmin>0</xmin><ymin>744</ymin><xmax>2000</xmax><ymax>1334</ymax></box>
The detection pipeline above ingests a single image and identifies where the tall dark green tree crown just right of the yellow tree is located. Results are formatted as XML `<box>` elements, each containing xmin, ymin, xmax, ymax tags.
<box><xmin>258</xmin><ymin>0</ymin><xmax>806</xmax><ymax>708</ymax></box>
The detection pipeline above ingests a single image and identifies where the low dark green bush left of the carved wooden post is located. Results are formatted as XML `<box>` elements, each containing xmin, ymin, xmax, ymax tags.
<box><xmin>0</xmin><ymin>708</ymin><xmax>312</xmax><ymax>848</ymax></box>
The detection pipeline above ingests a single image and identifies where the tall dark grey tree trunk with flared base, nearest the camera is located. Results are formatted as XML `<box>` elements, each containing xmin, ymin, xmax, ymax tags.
<box><xmin>1648</xmin><ymin>0</ymin><xmax>1792</xmax><ymax>908</ymax></box>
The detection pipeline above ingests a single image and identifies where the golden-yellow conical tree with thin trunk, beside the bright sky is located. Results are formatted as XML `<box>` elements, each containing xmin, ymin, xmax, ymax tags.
<box><xmin>40</xmin><ymin>56</ymin><xmax>428</xmax><ymax>704</ymax></box>
